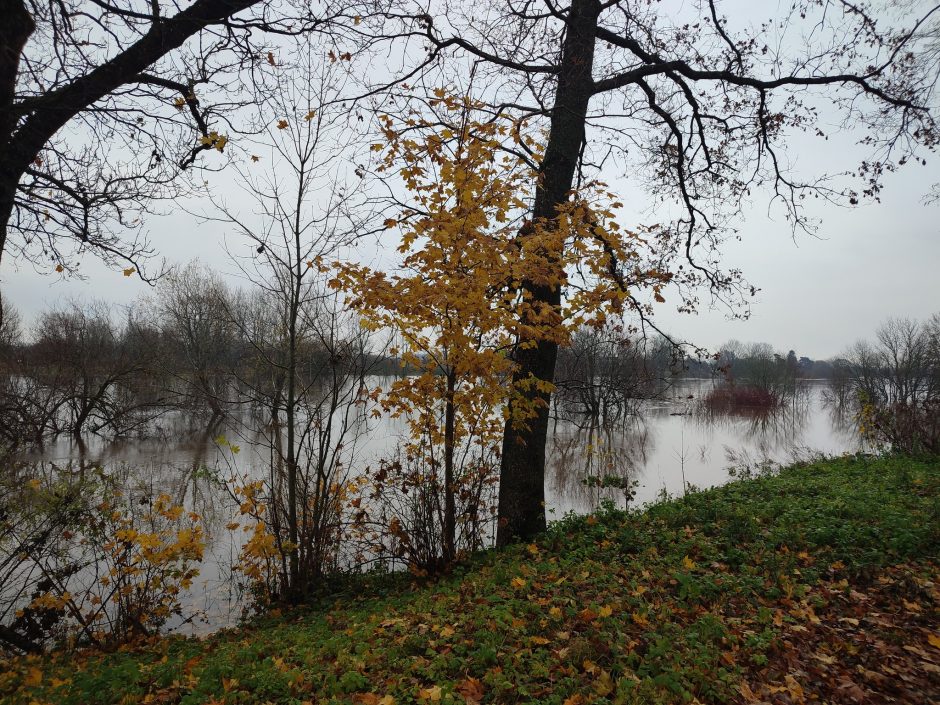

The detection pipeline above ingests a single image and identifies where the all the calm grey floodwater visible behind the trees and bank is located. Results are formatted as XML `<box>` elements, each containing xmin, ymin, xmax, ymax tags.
<box><xmin>9</xmin><ymin>380</ymin><xmax>863</xmax><ymax>633</ymax></box>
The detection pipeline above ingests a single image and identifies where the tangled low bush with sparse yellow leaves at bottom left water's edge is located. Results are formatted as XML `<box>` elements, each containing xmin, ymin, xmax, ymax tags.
<box><xmin>0</xmin><ymin>471</ymin><xmax>205</xmax><ymax>651</ymax></box>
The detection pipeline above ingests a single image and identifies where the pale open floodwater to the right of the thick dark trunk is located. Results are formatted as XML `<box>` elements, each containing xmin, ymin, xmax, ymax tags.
<box><xmin>546</xmin><ymin>380</ymin><xmax>864</xmax><ymax>516</ymax></box>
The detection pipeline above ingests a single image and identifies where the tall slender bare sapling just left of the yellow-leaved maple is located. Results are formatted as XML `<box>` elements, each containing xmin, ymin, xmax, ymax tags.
<box><xmin>219</xmin><ymin>48</ymin><xmax>384</xmax><ymax>600</ymax></box>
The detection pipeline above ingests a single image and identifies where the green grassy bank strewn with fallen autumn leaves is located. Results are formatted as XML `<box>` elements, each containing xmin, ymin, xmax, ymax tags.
<box><xmin>0</xmin><ymin>458</ymin><xmax>940</xmax><ymax>705</ymax></box>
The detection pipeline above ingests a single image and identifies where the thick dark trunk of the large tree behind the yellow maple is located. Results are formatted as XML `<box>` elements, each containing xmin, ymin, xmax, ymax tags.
<box><xmin>496</xmin><ymin>0</ymin><xmax>601</xmax><ymax>546</ymax></box>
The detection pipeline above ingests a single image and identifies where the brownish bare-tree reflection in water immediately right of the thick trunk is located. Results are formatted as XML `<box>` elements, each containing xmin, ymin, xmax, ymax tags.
<box><xmin>546</xmin><ymin>416</ymin><xmax>653</xmax><ymax>510</ymax></box>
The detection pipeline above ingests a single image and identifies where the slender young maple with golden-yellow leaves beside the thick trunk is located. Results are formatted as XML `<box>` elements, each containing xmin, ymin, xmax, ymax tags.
<box><xmin>332</xmin><ymin>102</ymin><xmax>674</xmax><ymax>561</ymax></box>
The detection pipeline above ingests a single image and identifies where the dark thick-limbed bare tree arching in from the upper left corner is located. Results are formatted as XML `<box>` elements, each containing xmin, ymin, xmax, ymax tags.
<box><xmin>0</xmin><ymin>0</ymin><xmax>398</xmax><ymax>271</ymax></box>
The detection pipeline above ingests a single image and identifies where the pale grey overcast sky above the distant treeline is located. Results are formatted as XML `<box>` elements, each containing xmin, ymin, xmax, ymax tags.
<box><xmin>0</xmin><ymin>3</ymin><xmax>940</xmax><ymax>358</ymax></box>
